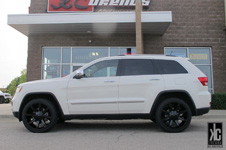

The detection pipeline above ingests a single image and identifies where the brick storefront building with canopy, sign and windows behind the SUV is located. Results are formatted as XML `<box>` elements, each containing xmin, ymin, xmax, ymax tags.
<box><xmin>8</xmin><ymin>0</ymin><xmax>226</xmax><ymax>93</ymax></box>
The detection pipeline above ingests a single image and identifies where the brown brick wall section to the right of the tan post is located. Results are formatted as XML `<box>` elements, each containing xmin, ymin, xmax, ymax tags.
<box><xmin>144</xmin><ymin>0</ymin><xmax>226</xmax><ymax>92</ymax></box>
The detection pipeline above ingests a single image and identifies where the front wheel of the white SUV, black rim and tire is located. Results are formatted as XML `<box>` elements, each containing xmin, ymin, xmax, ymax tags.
<box><xmin>22</xmin><ymin>99</ymin><xmax>58</xmax><ymax>133</ymax></box>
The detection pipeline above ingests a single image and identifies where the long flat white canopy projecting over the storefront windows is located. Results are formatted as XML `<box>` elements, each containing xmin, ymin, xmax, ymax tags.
<box><xmin>8</xmin><ymin>11</ymin><xmax>172</xmax><ymax>36</ymax></box>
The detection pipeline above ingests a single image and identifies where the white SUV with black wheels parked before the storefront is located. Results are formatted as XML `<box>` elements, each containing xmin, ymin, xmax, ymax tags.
<box><xmin>12</xmin><ymin>55</ymin><xmax>211</xmax><ymax>132</ymax></box>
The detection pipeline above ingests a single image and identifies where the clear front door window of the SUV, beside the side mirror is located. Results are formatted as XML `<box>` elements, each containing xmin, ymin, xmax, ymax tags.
<box><xmin>84</xmin><ymin>60</ymin><xmax>119</xmax><ymax>78</ymax></box>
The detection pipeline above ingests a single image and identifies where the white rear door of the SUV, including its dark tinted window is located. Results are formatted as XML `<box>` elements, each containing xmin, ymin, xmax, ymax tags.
<box><xmin>118</xmin><ymin>59</ymin><xmax>164</xmax><ymax>114</ymax></box>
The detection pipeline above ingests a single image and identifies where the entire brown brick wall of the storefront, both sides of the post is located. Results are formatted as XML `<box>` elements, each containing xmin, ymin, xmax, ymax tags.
<box><xmin>28</xmin><ymin>0</ymin><xmax>226</xmax><ymax>92</ymax></box>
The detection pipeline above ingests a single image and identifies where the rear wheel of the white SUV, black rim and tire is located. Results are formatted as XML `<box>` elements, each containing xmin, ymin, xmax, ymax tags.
<box><xmin>155</xmin><ymin>98</ymin><xmax>192</xmax><ymax>133</ymax></box>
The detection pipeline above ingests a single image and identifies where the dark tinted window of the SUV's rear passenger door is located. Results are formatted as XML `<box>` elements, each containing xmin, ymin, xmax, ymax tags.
<box><xmin>122</xmin><ymin>59</ymin><xmax>154</xmax><ymax>76</ymax></box>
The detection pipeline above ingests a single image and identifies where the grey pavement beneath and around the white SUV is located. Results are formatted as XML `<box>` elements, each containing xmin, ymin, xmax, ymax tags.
<box><xmin>0</xmin><ymin>104</ymin><xmax>226</xmax><ymax>150</ymax></box>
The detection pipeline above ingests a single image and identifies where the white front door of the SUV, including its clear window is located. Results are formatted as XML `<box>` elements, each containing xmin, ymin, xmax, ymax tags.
<box><xmin>68</xmin><ymin>60</ymin><xmax>119</xmax><ymax>114</ymax></box>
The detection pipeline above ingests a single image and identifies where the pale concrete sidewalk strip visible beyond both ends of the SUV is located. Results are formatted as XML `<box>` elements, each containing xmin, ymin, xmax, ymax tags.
<box><xmin>0</xmin><ymin>104</ymin><xmax>226</xmax><ymax>120</ymax></box>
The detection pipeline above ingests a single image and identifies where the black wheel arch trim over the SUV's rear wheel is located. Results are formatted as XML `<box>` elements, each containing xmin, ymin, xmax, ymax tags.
<box><xmin>150</xmin><ymin>90</ymin><xmax>197</xmax><ymax>118</ymax></box>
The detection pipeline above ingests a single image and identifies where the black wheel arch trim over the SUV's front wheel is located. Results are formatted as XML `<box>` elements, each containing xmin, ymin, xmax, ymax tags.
<box><xmin>19</xmin><ymin>92</ymin><xmax>63</xmax><ymax>121</ymax></box>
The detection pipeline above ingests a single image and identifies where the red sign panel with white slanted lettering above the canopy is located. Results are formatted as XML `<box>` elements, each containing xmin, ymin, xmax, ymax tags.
<box><xmin>48</xmin><ymin>0</ymin><xmax>151</xmax><ymax>12</ymax></box>
